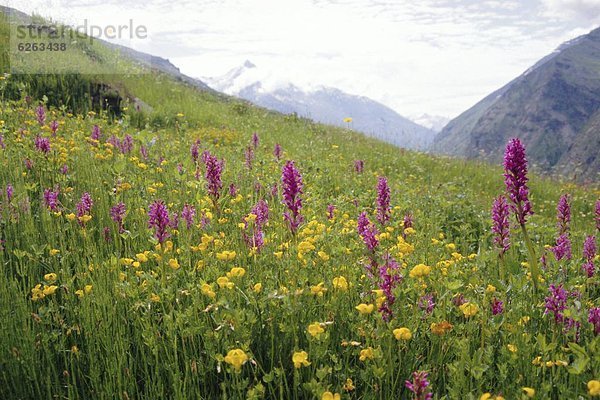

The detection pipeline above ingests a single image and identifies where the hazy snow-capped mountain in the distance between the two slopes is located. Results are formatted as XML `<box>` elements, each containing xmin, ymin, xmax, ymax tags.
<box><xmin>202</xmin><ymin>61</ymin><xmax>436</xmax><ymax>150</ymax></box>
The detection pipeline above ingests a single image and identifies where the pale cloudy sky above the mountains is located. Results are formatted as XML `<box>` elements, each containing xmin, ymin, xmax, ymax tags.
<box><xmin>2</xmin><ymin>0</ymin><xmax>600</xmax><ymax>117</ymax></box>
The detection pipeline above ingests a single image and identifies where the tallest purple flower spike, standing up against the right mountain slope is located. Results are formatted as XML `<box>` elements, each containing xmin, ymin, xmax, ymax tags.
<box><xmin>504</xmin><ymin>138</ymin><xmax>533</xmax><ymax>226</ymax></box>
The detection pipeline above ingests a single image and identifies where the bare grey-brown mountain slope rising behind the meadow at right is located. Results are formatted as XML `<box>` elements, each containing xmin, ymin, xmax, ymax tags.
<box><xmin>432</xmin><ymin>28</ymin><xmax>600</xmax><ymax>180</ymax></box>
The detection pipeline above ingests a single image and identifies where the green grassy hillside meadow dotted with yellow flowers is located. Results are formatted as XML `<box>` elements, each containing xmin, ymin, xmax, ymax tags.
<box><xmin>0</xmin><ymin>6</ymin><xmax>600</xmax><ymax>399</ymax></box>
